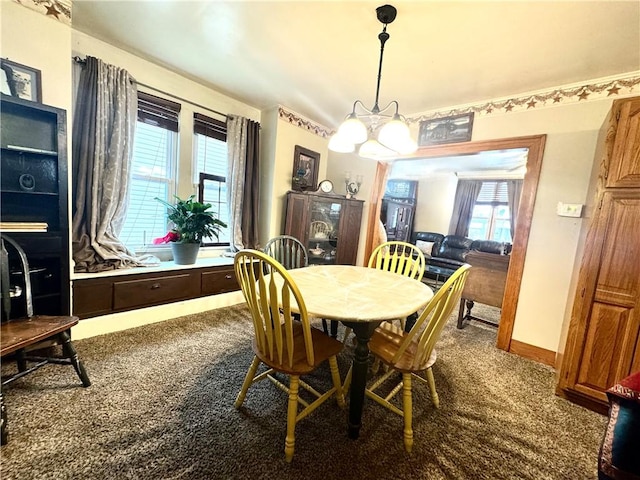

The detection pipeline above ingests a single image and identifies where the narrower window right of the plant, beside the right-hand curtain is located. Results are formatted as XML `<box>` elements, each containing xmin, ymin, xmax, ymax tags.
<box><xmin>193</xmin><ymin>113</ymin><xmax>229</xmax><ymax>245</ymax></box>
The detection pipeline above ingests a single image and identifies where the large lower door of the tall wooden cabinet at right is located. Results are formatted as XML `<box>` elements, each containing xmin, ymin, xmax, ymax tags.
<box><xmin>575</xmin><ymin>190</ymin><xmax>640</xmax><ymax>401</ymax></box>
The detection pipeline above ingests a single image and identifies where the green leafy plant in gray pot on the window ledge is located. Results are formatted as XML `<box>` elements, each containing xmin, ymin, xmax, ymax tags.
<box><xmin>154</xmin><ymin>195</ymin><xmax>227</xmax><ymax>265</ymax></box>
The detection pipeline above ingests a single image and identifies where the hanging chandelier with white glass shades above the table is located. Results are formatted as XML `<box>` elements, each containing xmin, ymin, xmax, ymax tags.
<box><xmin>329</xmin><ymin>5</ymin><xmax>418</xmax><ymax>160</ymax></box>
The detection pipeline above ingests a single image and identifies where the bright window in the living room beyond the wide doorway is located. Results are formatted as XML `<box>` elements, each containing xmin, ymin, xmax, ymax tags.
<box><xmin>469</xmin><ymin>181</ymin><xmax>511</xmax><ymax>243</ymax></box>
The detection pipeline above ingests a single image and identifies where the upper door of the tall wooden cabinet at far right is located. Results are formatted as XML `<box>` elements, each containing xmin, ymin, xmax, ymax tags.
<box><xmin>606</xmin><ymin>99</ymin><xmax>640</xmax><ymax>188</ymax></box>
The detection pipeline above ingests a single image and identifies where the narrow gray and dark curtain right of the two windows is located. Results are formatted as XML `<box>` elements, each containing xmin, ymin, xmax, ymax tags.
<box><xmin>227</xmin><ymin>116</ymin><xmax>260</xmax><ymax>251</ymax></box>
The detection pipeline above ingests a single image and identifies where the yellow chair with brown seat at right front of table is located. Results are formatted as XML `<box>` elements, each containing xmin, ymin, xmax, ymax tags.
<box><xmin>356</xmin><ymin>264</ymin><xmax>471</xmax><ymax>452</ymax></box>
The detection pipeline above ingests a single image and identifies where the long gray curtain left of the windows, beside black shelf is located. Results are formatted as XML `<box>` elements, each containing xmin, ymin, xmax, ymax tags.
<box><xmin>72</xmin><ymin>57</ymin><xmax>148</xmax><ymax>272</ymax></box>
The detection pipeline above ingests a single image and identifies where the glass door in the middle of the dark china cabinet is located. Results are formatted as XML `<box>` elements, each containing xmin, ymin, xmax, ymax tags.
<box><xmin>307</xmin><ymin>199</ymin><xmax>342</xmax><ymax>264</ymax></box>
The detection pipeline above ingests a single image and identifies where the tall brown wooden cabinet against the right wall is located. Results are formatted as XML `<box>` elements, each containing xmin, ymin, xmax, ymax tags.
<box><xmin>558</xmin><ymin>97</ymin><xmax>640</xmax><ymax>411</ymax></box>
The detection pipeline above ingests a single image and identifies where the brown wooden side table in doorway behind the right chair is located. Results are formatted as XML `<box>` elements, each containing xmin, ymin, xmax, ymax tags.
<box><xmin>458</xmin><ymin>251</ymin><xmax>510</xmax><ymax>328</ymax></box>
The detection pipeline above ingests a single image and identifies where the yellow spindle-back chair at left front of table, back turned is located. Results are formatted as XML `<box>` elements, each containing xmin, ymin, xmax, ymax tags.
<box><xmin>234</xmin><ymin>250</ymin><xmax>345</xmax><ymax>462</ymax></box>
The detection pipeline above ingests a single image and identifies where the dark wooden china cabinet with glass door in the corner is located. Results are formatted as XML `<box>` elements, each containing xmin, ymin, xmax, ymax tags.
<box><xmin>285</xmin><ymin>192</ymin><xmax>364</xmax><ymax>265</ymax></box>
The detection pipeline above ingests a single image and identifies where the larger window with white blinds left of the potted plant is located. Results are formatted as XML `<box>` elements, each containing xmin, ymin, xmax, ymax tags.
<box><xmin>120</xmin><ymin>92</ymin><xmax>180</xmax><ymax>250</ymax></box>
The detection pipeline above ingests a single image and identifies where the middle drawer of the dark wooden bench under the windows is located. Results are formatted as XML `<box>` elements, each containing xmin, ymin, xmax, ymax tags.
<box><xmin>113</xmin><ymin>273</ymin><xmax>200</xmax><ymax>310</ymax></box>
